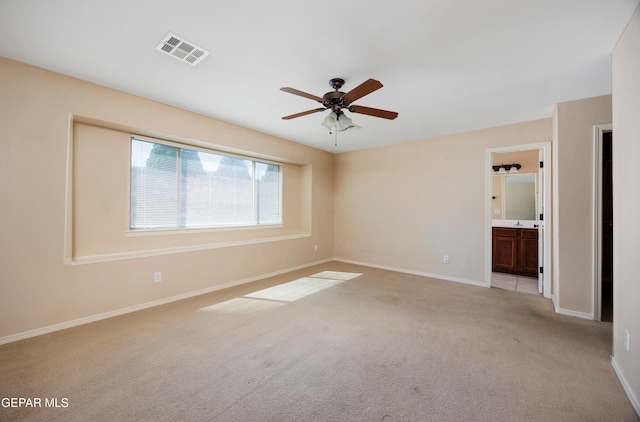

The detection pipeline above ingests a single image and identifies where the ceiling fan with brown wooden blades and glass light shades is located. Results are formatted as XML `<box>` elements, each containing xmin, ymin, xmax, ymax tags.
<box><xmin>280</xmin><ymin>78</ymin><xmax>398</xmax><ymax>131</ymax></box>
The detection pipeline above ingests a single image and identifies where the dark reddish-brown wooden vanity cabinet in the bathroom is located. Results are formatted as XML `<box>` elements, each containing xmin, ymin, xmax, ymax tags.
<box><xmin>492</xmin><ymin>227</ymin><xmax>538</xmax><ymax>277</ymax></box>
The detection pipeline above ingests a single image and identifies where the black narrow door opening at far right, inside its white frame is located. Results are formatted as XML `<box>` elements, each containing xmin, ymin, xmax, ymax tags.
<box><xmin>600</xmin><ymin>131</ymin><xmax>613</xmax><ymax>322</ymax></box>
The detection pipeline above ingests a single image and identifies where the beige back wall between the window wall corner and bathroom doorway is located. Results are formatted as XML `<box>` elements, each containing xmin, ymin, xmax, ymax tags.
<box><xmin>334</xmin><ymin>119</ymin><xmax>552</xmax><ymax>283</ymax></box>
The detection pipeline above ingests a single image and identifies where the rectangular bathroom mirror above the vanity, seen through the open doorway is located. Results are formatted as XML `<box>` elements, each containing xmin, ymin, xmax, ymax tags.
<box><xmin>500</xmin><ymin>173</ymin><xmax>537</xmax><ymax>220</ymax></box>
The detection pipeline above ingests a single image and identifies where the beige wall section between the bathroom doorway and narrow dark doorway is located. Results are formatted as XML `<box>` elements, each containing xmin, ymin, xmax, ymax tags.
<box><xmin>552</xmin><ymin>95</ymin><xmax>612</xmax><ymax>318</ymax></box>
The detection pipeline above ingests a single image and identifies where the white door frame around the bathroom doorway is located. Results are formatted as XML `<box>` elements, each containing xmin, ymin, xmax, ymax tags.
<box><xmin>484</xmin><ymin>141</ymin><xmax>553</xmax><ymax>299</ymax></box>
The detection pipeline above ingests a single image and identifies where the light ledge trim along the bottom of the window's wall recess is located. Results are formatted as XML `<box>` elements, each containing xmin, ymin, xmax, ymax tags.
<box><xmin>71</xmin><ymin>234</ymin><xmax>311</xmax><ymax>265</ymax></box>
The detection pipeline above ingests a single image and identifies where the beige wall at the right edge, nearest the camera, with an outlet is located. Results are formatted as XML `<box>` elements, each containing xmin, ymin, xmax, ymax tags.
<box><xmin>612</xmin><ymin>3</ymin><xmax>640</xmax><ymax>414</ymax></box>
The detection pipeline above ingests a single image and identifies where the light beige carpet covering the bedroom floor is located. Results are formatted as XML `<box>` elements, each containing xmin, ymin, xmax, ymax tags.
<box><xmin>0</xmin><ymin>262</ymin><xmax>638</xmax><ymax>422</ymax></box>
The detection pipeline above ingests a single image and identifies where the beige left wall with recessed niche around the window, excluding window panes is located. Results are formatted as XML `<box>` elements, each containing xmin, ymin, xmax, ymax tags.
<box><xmin>0</xmin><ymin>58</ymin><xmax>333</xmax><ymax>340</ymax></box>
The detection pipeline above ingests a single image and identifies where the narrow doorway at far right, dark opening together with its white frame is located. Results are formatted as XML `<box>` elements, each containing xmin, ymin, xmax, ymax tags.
<box><xmin>594</xmin><ymin>125</ymin><xmax>614</xmax><ymax>322</ymax></box>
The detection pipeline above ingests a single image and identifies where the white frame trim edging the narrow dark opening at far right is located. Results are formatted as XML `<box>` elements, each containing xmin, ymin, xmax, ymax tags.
<box><xmin>593</xmin><ymin>123</ymin><xmax>613</xmax><ymax>321</ymax></box>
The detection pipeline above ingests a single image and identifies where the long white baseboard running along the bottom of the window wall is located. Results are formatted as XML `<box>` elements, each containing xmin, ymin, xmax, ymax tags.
<box><xmin>0</xmin><ymin>258</ymin><xmax>332</xmax><ymax>345</ymax></box>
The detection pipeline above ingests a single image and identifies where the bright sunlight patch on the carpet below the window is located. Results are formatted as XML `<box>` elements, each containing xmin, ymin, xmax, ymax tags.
<box><xmin>200</xmin><ymin>271</ymin><xmax>362</xmax><ymax>313</ymax></box>
